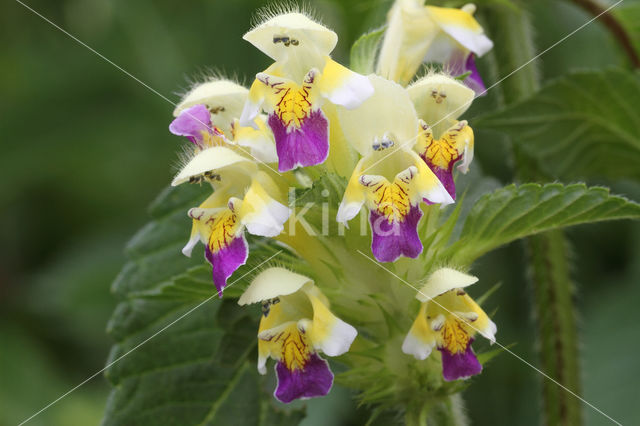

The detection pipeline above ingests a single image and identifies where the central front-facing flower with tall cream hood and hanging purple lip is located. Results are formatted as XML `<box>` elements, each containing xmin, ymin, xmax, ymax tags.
<box><xmin>336</xmin><ymin>75</ymin><xmax>453</xmax><ymax>262</ymax></box>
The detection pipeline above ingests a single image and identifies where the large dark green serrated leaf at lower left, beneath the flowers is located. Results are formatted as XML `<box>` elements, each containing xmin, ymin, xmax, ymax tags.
<box><xmin>103</xmin><ymin>186</ymin><xmax>304</xmax><ymax>426</ymax></box>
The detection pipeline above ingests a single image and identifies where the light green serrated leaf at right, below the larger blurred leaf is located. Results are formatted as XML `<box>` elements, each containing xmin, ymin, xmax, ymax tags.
<box><xmin>443</xmin><ymin>184</ymin><xmax>640</xmax><ymax>265</ymax></box>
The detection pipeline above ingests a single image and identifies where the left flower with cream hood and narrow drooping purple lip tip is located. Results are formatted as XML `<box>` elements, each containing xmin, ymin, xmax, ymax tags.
<box><xmin>172</xmin><ymin>146</ymin><xmax>290</xmax><ymax>297</ymax></box>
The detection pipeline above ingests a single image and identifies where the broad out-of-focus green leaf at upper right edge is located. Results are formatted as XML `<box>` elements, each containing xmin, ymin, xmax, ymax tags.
<box><xmin>474</xmin><ymin>69</ymin><xmax>640</xmax><ymax>179</ymax></box>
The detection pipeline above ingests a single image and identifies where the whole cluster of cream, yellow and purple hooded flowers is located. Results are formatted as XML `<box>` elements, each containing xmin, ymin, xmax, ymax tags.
<box><xmin>169</xmin><ymin>0</ymin><xmax>496</xmax><ymax>402</ymax></box>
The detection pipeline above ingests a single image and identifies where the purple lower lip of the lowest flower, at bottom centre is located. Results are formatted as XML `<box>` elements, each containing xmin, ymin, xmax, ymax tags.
<box><xmin>273</xmin><ymin>353</ymin><xmax>333</xmax><ymax>404</ymax></box>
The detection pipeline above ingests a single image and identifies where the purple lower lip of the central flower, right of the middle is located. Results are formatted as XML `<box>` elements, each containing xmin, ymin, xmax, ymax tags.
<box><xmin>369</xmin><ymin>206</ymin><xmax>422</xmax><ymax>262</ymax></box>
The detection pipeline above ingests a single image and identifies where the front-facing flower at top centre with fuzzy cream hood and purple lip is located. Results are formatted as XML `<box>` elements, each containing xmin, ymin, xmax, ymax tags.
<box><xmin>240</xmin><ymin>12</ymin><xmax>373</xmax><ymax>172</ymax></box>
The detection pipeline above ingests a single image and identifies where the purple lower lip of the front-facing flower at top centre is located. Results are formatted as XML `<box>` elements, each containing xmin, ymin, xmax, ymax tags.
<box><xmin>269</xmin><ymin>109</ymin><xmax>329</xmax><ymax>172</ymax></box>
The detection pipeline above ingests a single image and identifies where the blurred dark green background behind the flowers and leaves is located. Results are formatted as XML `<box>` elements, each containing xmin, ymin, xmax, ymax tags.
<box><xmin>0</xmin><ymin>0</ymin><xmax>640</xmax><ymax>425</ymax></box>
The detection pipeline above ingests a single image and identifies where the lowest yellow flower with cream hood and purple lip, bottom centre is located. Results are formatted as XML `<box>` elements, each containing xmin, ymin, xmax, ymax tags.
<box><xmin>238</xmin><ymin>268</ymin><xmax>357</xmax><ymax>403</ymax></box>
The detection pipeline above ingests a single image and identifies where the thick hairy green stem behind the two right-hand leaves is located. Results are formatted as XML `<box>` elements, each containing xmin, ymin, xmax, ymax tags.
<box><xmin>489</xmin><ymin>2</ymin><xmax>582</xmax><ymax>425</ymax></box>
